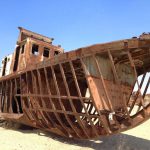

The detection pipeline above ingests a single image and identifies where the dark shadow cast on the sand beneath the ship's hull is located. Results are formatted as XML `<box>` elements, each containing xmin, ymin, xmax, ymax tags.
<box><xmin>19</xmin><ymin>127</ymin><xmax>150</xmax><ymax>150</ymax></box>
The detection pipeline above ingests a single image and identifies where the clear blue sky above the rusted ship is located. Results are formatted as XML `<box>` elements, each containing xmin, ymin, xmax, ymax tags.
<box><xmin>0</xmin><ymin>0</ymin><xmax>150</xmax><ymax>59</ymax></box>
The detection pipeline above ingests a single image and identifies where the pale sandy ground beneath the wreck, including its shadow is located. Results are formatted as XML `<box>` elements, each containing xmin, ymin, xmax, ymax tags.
<box><xmin>0</xmin><ymin>120</ymin><xmax>150</xmax><ymax>150</ymax></box>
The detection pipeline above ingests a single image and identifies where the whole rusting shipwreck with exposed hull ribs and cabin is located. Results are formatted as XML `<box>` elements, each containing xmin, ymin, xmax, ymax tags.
<box><xmin>0</xmin><ymin>28</ymin><xmax>150</xmax><ymax>139</ymax></box>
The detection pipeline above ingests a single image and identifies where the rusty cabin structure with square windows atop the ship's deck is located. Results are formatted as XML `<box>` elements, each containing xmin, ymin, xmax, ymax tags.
<box><xmin>0</xmin><ymin>27</ymin><xmax>64</xmax><ymax>76</ymax></box>
